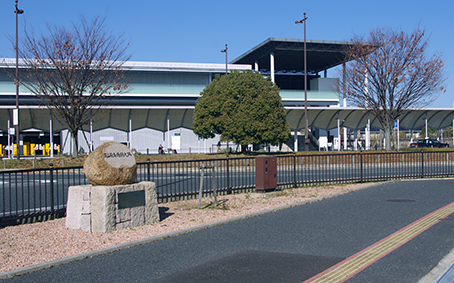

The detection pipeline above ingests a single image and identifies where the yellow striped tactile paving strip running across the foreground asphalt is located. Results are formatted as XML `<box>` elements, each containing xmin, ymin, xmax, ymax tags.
<box><xmin>303</xmin><ymin>202</ymin><xmax>454</xmax><ymax>283</ymax></box>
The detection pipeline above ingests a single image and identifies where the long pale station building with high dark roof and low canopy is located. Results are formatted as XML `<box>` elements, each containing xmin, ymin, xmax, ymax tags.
<box><xmin>0</xmin><ymin>38</ymin><xmax>454</xmax><ymax>157</ymax></box>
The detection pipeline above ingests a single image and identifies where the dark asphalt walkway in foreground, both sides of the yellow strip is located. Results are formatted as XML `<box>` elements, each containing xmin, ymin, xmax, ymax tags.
<box><xmin>5</xmin><ymin>179</ymin><xmax>454</xmax><ymax>283</ymax></box>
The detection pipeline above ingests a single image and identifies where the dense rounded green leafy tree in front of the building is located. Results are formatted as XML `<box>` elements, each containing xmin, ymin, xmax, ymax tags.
<box><xmin>192</xmin><ymin>70</ymin><xmax>290</xmax><ymax>150</ymax></box>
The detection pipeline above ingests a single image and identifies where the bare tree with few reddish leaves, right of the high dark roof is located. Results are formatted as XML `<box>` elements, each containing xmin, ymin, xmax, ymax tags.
<box><xmin>342</xmin><ymin>28</ymin><xmax>446</xmax><ymax>150</ymax></box>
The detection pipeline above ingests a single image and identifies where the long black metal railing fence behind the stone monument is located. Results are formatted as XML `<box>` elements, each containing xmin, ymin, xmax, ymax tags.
<box><xmin>0</xmin><ymin>151</ymin><xmax>454</xmax><ymax>222</ymax></box>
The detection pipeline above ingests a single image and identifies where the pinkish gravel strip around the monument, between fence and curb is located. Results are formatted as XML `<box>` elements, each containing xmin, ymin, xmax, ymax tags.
<box><xmin>0</xmin><ymin>184</ymin><xmax>367</xmax><ymax>272</ymax></box>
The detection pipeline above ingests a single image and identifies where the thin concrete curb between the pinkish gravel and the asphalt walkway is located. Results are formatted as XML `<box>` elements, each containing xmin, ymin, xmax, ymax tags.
<box><xmin>0</xmin><ymin>180</ymin><xmax>388</xmax><ymax>280</ymax></box>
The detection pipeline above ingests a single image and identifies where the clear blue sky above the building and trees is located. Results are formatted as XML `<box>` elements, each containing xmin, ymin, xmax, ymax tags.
<box><xmin>0</xmin><ymin>0</ymin><xmax>454</xmax><ymax>107</ymax></box>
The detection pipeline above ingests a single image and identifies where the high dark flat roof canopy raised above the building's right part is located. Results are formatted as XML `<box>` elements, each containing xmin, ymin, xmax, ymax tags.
<box><xmin>231</xmin><ymin>37</ymin><xmax>351</xmax><ymax>73</ymax></box>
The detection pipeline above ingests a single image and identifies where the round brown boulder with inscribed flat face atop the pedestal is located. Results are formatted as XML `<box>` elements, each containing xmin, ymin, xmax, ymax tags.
<box><xmin>84</xmin><ymin>142</ymin><xmax>137</xmax><ymax>186</ymax></box>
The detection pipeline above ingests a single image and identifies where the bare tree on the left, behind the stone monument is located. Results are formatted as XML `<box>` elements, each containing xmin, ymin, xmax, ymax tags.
<box><xmin>20</xmin><ymin>16</ymin><xmax>130</xmax><ymax>156</ymax></box>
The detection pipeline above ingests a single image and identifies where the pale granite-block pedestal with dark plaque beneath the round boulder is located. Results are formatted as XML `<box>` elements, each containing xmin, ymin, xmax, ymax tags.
<box><xmin>66</xmin><ymin>182</ymin><xmax>159</xmax><ymax>232</ymax></box>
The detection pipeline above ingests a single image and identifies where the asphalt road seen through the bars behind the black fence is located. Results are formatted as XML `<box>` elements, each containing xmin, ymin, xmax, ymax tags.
<box><xmin>0</xmin><ymin>164</ymin><xmax>452</xmax><ymax>219</ymax></box>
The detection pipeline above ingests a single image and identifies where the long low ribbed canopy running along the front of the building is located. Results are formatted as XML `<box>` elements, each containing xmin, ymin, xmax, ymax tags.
<box><xmin>0</xmin><ymin>106</ymin><xmax>454</xmax><ymax>132</ymax></box>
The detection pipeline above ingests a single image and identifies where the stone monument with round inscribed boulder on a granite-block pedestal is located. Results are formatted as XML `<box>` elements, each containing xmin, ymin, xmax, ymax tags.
<box><xmin>66</xmin><ymin>142</ymin><xmax>159</xmax><ymax>232</ymax></box>
